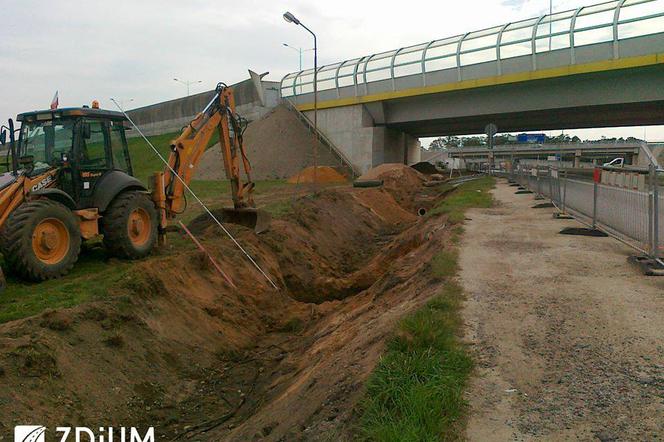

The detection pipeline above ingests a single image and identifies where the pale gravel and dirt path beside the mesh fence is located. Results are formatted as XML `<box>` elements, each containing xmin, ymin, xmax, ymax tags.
<box><xmin>461</xmin><ymin>183</ymin><xmax>664</xmax><ymax>441</ymax></box>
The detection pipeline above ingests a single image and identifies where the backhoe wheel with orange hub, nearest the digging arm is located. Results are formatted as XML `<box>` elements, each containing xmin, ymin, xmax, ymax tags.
<box><xmin>102</xmin><ymin>191</ymin><xmax>158</xmax><ymax>259</ymax></box>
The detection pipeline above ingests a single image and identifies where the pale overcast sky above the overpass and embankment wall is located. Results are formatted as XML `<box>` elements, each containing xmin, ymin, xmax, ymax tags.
<box><xmin>0</xmin><ymin>0</ymin><xmax>664</xmax><ymax>139</ymax></box>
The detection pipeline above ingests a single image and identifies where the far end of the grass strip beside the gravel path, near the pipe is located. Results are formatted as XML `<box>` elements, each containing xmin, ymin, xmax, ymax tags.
<box><xmin>429</xmin><ymin>177</ymin><xmax>495</xmax><ymax>224</ymax></box>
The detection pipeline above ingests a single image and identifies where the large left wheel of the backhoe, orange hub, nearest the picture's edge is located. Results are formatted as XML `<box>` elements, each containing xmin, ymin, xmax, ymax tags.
<box><xmin>2</xmin><ymin>199</ymin><xmax>81</xmax><ymax>281</ymax></box>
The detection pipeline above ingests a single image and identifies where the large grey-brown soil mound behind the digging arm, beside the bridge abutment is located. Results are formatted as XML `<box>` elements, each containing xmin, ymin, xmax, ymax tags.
<box><xmin>196</xmin><ymin>106</ymin><xmax>340</xmax><ymax>180</ymax></box>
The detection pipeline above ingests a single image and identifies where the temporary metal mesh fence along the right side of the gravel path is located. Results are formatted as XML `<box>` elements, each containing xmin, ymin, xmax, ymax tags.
<box><xmin>504</xmin><ymin>165</ymin><xmax>664</xmax><ymax>265</ymax></box>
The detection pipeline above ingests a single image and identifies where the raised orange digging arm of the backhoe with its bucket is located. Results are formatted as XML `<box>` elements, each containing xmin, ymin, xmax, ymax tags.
<box><xmin>151</xmin><ymin>83</ymin><xmax>269</xmax><ymax>238</ymax></box>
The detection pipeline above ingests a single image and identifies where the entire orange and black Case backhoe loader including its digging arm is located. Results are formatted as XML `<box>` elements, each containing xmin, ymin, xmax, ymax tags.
<box><xmin>0</xmin><ymin>83</ymin><xmax>269</xmax><ymax>286</ymax></box>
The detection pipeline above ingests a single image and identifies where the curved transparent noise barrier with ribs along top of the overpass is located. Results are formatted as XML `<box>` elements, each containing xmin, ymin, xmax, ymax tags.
<box><xmin>281</xmin><ymin>0</ymin><xmax>664</xmax><ymax>97</ymax></box>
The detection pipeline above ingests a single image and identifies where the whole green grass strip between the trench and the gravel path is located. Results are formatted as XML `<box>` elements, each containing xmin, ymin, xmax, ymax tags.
<box><xmin>357</xmin><ymin>178</ymin><xmax>494</xmax><ymax>442</ymax></box>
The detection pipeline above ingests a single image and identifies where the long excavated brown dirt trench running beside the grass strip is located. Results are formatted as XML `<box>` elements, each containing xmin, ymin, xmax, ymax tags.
<box><xmin>0</xmin><ymin>167</ymin><xmax>450</xmax><ymax>441</ymax></box>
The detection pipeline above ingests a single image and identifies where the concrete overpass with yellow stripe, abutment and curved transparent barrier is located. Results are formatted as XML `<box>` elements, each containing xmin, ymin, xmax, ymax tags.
<box><xmin>280</xmin><ymin>0</ymin><xmax>664</xmax><ymax>173</ymax></box>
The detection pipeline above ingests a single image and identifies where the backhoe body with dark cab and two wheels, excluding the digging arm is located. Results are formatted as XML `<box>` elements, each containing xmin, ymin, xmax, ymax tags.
<box><xmin>0</xmin><ymin>107</ymin><xmax>158</xmax><ymax>281</ymax></box>
